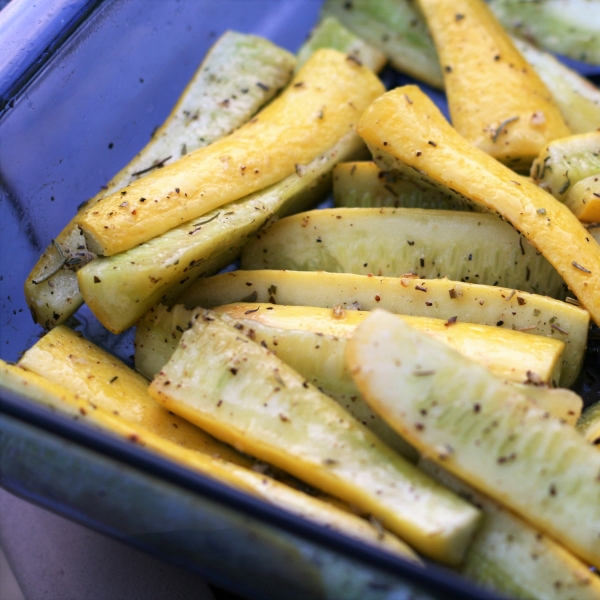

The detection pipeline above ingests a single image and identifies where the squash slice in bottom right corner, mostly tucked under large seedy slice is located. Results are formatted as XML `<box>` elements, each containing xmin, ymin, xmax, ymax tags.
<box><xmin>419</xmin><ymin>460</ymin><xmax>600</xmax><ymax>600</ymax></box>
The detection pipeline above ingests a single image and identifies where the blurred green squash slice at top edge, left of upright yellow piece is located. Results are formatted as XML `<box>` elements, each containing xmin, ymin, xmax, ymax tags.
<box><xmin>321</xmin><ymin>0</ymin><xmax>443</xmax><ymax>88</ymax></box>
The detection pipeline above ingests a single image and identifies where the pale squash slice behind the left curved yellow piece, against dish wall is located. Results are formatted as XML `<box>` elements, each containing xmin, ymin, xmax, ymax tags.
<box><xmin>25</xmin><ymin>31</ymin><xmax>295</xmax><ymax>329</ymax></box>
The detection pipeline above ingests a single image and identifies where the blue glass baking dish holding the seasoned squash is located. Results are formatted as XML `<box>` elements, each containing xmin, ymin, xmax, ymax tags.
<box><xmin>0</xmin><ymin>0</ymin><xmax>600</xmax><ymax>600</ymax></box>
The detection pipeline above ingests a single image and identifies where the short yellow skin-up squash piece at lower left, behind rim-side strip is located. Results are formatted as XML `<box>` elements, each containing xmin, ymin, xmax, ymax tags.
<box><xmin>18</xmin><ymin>325</ymin><xmax>252</xmax><ymax>466</ymax></box>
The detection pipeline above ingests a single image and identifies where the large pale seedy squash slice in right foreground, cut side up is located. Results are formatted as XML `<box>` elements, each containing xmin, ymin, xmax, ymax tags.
<box><xmin>346</xmin><ymin>311</ymin><xmax>600</xmax><ymax>566</ymax></box>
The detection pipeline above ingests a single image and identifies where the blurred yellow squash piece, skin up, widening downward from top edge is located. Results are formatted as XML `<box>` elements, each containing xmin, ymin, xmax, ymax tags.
<box><xmin>418</xmin><ymin>0</ymin><xmax>571</xmax><ymax>170</ymax></box>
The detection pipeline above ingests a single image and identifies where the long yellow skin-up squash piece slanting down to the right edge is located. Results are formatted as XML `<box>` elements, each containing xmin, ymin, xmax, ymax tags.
<box><xmin>358</xmin><ymin>86</ymin><xmax>600</xmax><ymax>323</ymax></box>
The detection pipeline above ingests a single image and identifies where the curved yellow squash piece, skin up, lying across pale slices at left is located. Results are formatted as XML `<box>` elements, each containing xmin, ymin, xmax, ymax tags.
<box><xmin>79</xmin><ymin>49</ymin><xmax>384</xmax><ymax>256</ymax></box>
